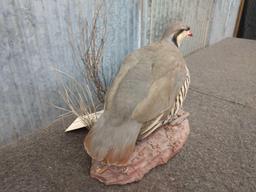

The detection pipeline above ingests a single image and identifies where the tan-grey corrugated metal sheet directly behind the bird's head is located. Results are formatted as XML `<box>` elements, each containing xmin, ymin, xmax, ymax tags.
<box><xmin>141</xmin><ymin>0</ymin><xmax>214</xmax><ymax>54</ymax></box>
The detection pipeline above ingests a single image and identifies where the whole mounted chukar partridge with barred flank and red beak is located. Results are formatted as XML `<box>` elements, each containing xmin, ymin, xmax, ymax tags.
<box><xmin>84</xmin><ymin>22</ymin><xmax>192</xmax><ymax>166</ymax></box>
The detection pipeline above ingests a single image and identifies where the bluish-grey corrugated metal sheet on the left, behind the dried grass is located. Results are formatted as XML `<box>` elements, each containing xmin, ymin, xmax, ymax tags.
<box><xmin>0</xmin><ymin>0</ymin><xmax>139</xmax><ymax>143</ymax></box>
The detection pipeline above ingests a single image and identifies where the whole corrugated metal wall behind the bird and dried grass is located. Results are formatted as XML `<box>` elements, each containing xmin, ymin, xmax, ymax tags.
<box><xmin>0</xmin><ymin>0</ymin><xmax>240</xmax><ymax>143</ymax></box>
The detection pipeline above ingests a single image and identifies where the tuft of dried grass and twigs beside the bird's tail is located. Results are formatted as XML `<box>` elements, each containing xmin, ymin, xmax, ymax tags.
<box><xmin>55</xmin><ymin>1</ymin><xmax>107</xmax><ymax>128</ymax></box>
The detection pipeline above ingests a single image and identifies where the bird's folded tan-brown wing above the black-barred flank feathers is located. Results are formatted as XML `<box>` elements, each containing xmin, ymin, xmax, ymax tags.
<box><xmin>132</xmin><ymin>60</ymin><xmax>186</xmax><ymax>123</ymax></box>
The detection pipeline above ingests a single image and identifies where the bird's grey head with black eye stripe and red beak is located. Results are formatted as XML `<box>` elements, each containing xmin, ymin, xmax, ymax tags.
<box><xmin>162</xmin><ymin>22</ymin><xmax>192</xmax><ymax>47</ymax></box>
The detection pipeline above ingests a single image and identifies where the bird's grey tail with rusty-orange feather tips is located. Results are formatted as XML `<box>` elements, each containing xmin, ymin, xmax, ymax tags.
<box><xmin>84</xmin><ymin>112</ymin><xmax>141</xmax><ymax>165</ymax></box>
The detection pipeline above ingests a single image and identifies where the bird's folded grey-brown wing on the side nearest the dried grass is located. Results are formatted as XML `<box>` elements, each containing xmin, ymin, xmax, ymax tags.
<box><xmin>105</xmin><ymin>44</ymin><xmax>154</xmax><ymax>119</ymax></box>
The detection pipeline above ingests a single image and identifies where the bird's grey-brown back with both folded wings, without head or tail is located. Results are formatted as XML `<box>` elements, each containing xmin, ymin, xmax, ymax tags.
<box><xmin>105</xmin><ymin>43</ymin><xmax>186</xmax><ymax>123</ymax></box>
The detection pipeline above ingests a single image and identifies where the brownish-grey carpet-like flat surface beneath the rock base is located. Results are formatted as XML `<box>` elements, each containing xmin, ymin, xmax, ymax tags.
<box><xmin>0</xmin><ymin>38</ymin><xmax>256</xmax><ymax>192</ymax></box>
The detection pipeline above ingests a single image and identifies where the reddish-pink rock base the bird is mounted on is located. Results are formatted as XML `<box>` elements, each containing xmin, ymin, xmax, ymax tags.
<box><xmin>90</xmin><ymin>119</ymin><xmax>189</xmax><ymax>185</ymax></box>
